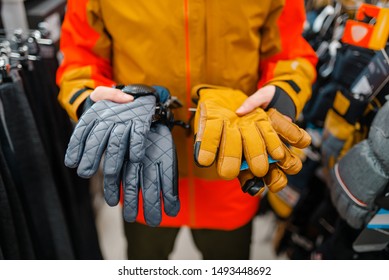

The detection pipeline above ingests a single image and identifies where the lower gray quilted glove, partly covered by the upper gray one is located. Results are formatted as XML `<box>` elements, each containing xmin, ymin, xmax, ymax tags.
<box><xmin>123</xmin><ymin>123</ymin><xmax>180</xmax><ymax>226</ymax></box>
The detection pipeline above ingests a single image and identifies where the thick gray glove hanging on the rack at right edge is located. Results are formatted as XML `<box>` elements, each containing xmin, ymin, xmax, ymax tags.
<box><xmin>328</xmin><ymin>102</ymin><xmax>389</xmax><ymax>228</ymax></box>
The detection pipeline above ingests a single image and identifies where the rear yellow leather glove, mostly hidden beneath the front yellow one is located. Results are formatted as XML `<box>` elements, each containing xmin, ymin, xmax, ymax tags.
<box><xmin>239</xmin><ymin>108</ymin><xmax>311</xmax><ymax>196</ymax></box>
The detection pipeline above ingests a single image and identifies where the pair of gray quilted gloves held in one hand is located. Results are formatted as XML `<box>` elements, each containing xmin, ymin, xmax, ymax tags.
<box><xmin>65</xmin><ymin>85</ymin><xmax>180</xmax><ymax>226</ymax></box>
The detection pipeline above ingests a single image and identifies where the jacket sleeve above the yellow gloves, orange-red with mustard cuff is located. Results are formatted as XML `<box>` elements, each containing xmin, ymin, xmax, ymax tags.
<box><xmin>258</xmin><ymin>0</ymin><xmax>317</xmax><ymax>117</ymax></box>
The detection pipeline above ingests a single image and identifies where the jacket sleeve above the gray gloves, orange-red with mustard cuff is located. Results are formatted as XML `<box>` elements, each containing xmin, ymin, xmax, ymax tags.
<box><xmin>57</xmin><ymin>0</ymin><xmax>114</xmax><ymax>121</ymax></box>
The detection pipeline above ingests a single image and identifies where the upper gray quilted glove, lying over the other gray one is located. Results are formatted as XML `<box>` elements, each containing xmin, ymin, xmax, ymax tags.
<box><xmin>65</xmin><ymin>85</ymin><xmax>156</xmax><ymax>206</ymax></box>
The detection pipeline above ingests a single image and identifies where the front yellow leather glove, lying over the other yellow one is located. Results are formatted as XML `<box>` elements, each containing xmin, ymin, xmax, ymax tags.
<box><xmin>193</xmin><ymin>85</ymin><xmax>310</xmax><ymax>182</ymax></box>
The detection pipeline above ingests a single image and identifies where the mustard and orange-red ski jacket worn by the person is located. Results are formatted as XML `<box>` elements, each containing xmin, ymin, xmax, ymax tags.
<box><xmin>57</xmin><ymin>0</ymin><xmax>317</xmax><ymax>230</ymax></box>
